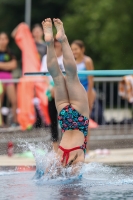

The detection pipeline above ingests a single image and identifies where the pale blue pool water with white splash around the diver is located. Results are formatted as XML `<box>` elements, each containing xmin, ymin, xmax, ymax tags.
<box><xmin>0</xmin><ymin>141</ymin><xmax>133</xmax><ymax>200</ymax></box>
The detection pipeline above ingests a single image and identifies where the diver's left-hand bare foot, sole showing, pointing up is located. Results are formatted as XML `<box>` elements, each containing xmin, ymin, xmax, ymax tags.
<box><xmin>42</xmin><ymin>18</ymin><xmax>53</xmax><ymax>43</ymax></box>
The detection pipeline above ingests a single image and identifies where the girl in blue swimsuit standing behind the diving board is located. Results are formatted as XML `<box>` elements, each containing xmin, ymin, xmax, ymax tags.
<box><xmin>71</xmin><ymin>40</ymin><xmax>96</xmax><ymax>114</ymax></box>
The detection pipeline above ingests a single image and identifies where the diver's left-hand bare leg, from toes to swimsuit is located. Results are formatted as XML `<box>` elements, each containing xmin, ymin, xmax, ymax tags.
<box><xmin>42</xmin><ymin>18</ymin><xmax>69</xmax><ymax>113</ymax></box>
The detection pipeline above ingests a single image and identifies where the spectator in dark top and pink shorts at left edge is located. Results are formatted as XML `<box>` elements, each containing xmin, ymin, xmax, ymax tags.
<box><xmin>0</xmin><ymin>32</ymin><xmax>18</xmax><ymax>127</ymax></box>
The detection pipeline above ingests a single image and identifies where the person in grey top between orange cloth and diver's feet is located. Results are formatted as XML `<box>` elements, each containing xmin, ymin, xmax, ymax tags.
<box><xmin>32</xmin><ymin>24</ymin><xmax>47</xmax><ymax>60</ymax></box>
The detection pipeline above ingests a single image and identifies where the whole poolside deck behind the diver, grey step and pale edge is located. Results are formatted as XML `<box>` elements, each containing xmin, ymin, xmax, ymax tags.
<box><xmin>0</xmin><ymin>125</ymin><xmax>133</xmax><ymax>166</ymax></box>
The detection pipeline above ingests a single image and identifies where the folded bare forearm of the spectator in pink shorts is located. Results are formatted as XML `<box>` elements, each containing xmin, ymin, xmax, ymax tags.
<box><xmin>0</xmin><ymin>59</ymin><xmax>17</xmax><ymax>71</ymax></box>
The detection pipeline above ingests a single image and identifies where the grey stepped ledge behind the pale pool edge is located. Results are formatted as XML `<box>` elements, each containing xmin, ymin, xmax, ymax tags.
<box><xmin>0</xmin><ymin>125</ymin><xmax>133</xmax><ymax>155</ymax></box>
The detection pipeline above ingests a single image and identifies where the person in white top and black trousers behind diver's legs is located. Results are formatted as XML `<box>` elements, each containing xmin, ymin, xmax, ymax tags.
<box><xmin>41</xmin><ymin>38</ymin><xmax>64</xmax><ymax>152</ymax></box>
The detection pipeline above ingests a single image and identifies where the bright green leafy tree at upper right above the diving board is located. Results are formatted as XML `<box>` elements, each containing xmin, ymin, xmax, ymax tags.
<box><xmin>63</xmin><ymin>0</ymin><xmax>133</xmax><ymax>69</ymax></box>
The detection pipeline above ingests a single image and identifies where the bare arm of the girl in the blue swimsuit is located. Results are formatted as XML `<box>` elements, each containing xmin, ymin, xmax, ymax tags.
<box><xmin>85</xmin><ymin>57</ymin><xmax>94</xmax><ymax>112</ymax></box>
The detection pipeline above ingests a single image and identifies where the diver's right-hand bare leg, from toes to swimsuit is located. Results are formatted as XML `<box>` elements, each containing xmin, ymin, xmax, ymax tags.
<box><xmin>54</xmin><ymin>19</ymin><xmax>89</xmax><ymax>118</ymax></box>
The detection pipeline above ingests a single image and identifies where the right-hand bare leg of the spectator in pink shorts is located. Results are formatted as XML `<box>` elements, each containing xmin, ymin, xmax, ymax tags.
<box><xmin>6</xmin><ymin>84</ymin><xmax>17</xmax><ymax>123</ymax></box>
